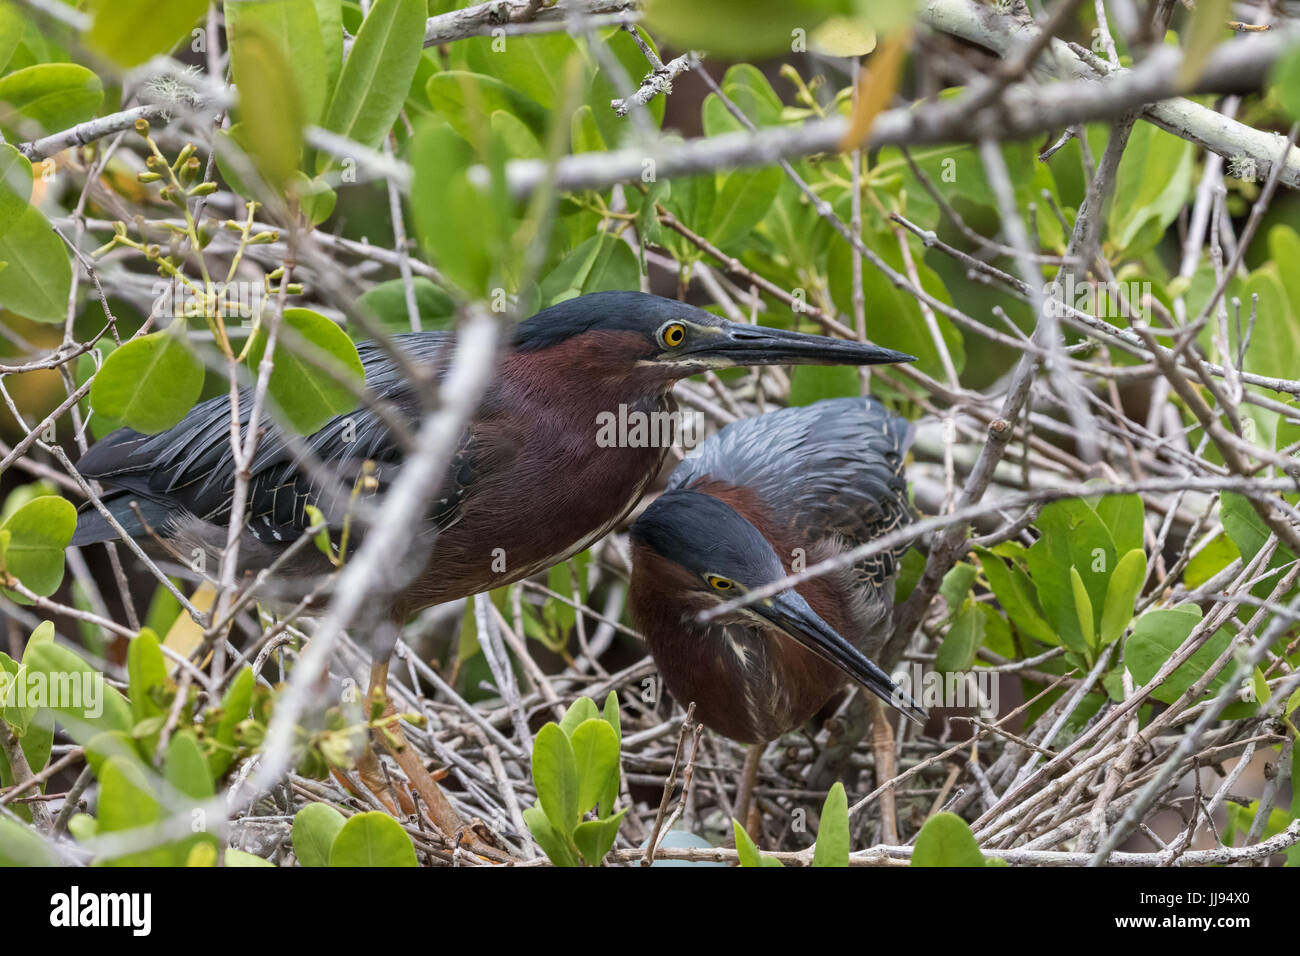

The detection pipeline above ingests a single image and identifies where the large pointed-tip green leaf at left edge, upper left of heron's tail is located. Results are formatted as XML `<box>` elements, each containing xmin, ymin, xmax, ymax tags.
<box><xmin>0</xmin><ymin>206</ymin><xmax>73</xmax><ymax>323</ymax></box>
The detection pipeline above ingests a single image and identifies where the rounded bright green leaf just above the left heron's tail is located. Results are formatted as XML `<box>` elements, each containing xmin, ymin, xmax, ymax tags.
<box><xmin>90</xmin><ymin>324</ymin><xmax>203</xmax><ymax>434</ymax></box>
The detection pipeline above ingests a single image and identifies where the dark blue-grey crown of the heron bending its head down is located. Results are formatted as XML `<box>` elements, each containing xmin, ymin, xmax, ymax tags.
<box><xmin>631</xmin><ymin>488</ymin><xmax>785</xmax><ymax>588</ymax></box>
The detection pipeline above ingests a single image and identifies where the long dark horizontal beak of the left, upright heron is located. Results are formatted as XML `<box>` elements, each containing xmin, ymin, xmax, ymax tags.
<box><xmin>680</xmin><ymin>323</ymin><xmax>917</xmax><ymax>367</ymax></box>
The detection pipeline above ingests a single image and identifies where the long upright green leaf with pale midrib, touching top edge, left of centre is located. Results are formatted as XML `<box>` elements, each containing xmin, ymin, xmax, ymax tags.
<box><xmin>316</xmin><ymin>0</ymin><xmax>426</xmax><ymax>166</ymax></box>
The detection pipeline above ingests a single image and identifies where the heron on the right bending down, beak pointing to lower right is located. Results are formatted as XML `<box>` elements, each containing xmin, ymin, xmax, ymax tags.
<box><xmin>628</xmin><ymin>398</ymin><xmax>926</xmax><ymax>822</ymax></box>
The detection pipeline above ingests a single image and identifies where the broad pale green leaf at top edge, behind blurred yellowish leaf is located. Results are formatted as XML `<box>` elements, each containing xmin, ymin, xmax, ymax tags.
<box><xmin>225</xmin><ymin>0</ymin><xmax>325</xmax><ymax>124</ymax></box>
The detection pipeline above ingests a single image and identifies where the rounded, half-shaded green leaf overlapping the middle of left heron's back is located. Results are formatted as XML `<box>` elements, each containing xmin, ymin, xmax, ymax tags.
<box><xmin>248</xmin><ymin>308</ymin><xmax>365</xmax><ymax>434</ymax></box>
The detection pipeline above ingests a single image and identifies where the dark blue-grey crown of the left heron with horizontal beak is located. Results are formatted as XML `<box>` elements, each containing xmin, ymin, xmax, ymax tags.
<box><xmin>515</xmin><ymin>291</ymin><xmax>718</xmax><ymax>352</ymax></box>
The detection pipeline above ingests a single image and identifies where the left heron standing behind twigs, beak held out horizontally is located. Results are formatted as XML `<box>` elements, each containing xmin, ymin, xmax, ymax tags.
<box><xmin>73</xmin><ymin>291</ymin><xmax>913</xmax><ymax>842</ymax></box>
